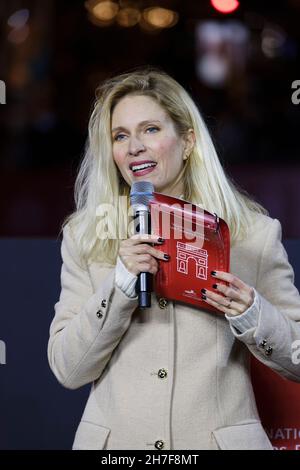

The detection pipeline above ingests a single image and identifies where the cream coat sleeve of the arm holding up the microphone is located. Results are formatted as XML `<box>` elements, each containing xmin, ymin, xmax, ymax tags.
<box><xmin>48</xmin><ymin>225</ymin><xmax>138</xmax><ymax>389</ymax></box>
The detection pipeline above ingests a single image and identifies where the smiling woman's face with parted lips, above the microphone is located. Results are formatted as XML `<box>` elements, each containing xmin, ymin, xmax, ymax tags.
<box><xmin>111</xmin><ymin>95</ymin><xmax>191</xmax><ymax>196</ymax></box>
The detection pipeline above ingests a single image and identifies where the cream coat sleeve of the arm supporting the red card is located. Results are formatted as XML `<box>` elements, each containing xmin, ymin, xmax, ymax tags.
<box><xmin>227</xmin><ymin>219</ymin><xmax>300</xmax><ymax>382</ymax></box>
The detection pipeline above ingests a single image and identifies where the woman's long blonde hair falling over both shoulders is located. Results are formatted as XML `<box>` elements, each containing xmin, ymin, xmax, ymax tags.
<box><xmin>62</xmin><ymin>68</ymin><xmax>268</xmax><ymax>264</ymax></box>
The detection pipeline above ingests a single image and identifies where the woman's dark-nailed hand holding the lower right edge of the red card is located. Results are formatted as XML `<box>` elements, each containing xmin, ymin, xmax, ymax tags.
<box><xmin>201</xmin><ymin>271</ymin><xmax>255</xmax><ymax>316</ymax></box>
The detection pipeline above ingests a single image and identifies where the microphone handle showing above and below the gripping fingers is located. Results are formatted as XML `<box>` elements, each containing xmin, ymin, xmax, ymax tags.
<box><xmin>135</xmin><ymin>210</ymin><xmax>153</xmax><ymax>308</ymax></box>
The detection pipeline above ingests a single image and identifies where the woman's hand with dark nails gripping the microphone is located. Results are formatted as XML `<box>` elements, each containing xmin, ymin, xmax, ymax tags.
<box><xmin>119</xmin><ymin>234</ymin><xmax>169</xmax><ymax>276</ymax></box>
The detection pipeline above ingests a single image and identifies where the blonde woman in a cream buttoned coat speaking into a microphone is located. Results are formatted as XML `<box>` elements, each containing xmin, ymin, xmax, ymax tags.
<box><xmin>48</xmin><ymin>69</ymin><xmax>300</xmax><ymax>450</ymax></box>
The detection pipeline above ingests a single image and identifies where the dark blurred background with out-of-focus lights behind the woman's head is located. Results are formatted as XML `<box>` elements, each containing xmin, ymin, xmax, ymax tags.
<box><xmin>0</xmin><ymin>0</ymin><xmax>300</xmax><ymax>238</ymax></box>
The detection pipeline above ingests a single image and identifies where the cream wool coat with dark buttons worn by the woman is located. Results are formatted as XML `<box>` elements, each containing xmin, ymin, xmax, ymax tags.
<box><xmin>48</xmin><ymin>214</ymin><xmax>300</xmax><ymax>450</ymax></box>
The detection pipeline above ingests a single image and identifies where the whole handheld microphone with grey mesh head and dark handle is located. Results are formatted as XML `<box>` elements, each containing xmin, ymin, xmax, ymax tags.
<box><xmin>130</xmin><ymin>181</ymin><xmax>154</xmax><ymax>308</ymax></box>
